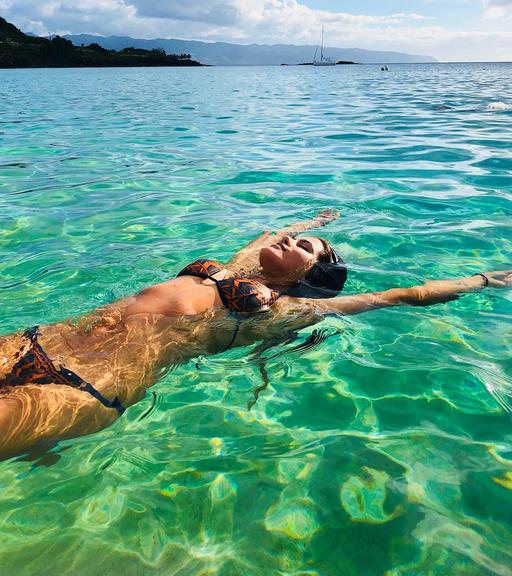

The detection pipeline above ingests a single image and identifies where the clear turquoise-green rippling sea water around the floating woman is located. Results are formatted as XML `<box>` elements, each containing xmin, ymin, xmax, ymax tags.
<box><xmin>0</xmin><ymin>64</ymin><xmax>512</xmax><ymax>576</ymax></box>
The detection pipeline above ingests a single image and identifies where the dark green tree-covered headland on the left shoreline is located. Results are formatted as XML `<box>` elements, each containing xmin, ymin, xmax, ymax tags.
<box><xmin>0</xmin><ymin>17</ymin><xmax>202</xmax><ymax>68</ymax></box>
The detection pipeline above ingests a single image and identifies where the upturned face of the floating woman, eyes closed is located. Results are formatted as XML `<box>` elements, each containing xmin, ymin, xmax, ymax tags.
<box><xmin>260</xmin><ymin>236</ymin><xmax>324</xmax><ymax>279</ymax></box>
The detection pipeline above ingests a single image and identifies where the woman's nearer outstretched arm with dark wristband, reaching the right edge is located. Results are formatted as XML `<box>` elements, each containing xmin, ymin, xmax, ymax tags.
<box><xmin>282</xmin><ymin>270</ymin><xmax>512</xmax><ymax>315</ymax></box>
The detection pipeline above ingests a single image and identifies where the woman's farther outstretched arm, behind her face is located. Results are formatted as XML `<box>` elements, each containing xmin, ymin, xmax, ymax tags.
<box><xmin>227</xmin><ymin>210</ymin><xmax>339</xmax><ymax>271</ymax></box>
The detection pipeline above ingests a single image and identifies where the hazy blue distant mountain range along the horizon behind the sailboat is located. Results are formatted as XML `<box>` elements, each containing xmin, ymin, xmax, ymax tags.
<box><xmin>64</xmin><ymin>34</ymin><xmax>436</xmax><ymax>66</ymax></box>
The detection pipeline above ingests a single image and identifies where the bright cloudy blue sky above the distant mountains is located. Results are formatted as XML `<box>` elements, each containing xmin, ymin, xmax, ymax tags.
<box><xmin>0</xmin><ymin>0</ymin><xmax>512</xmax><ymax>61</ymax></box>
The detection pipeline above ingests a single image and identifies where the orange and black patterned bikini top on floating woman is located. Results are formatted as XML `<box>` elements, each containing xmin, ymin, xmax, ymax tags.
<box><xmin>178</xmin><ymin>259</ymin><xmax>279</xmax><ymax>314</ymax></box>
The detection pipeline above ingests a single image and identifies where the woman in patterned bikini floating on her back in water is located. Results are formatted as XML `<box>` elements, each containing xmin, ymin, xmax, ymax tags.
<box><xmin>0</xmin><ymin>210</ymin><xmax>512</xmax><ymax>458</ymax></box>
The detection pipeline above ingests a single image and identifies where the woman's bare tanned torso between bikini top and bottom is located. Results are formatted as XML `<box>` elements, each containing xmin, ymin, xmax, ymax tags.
<box><xmin>0</xmin><ymin>268</ymin><xmax>280</xmax><ymax>405</ymax></box>
